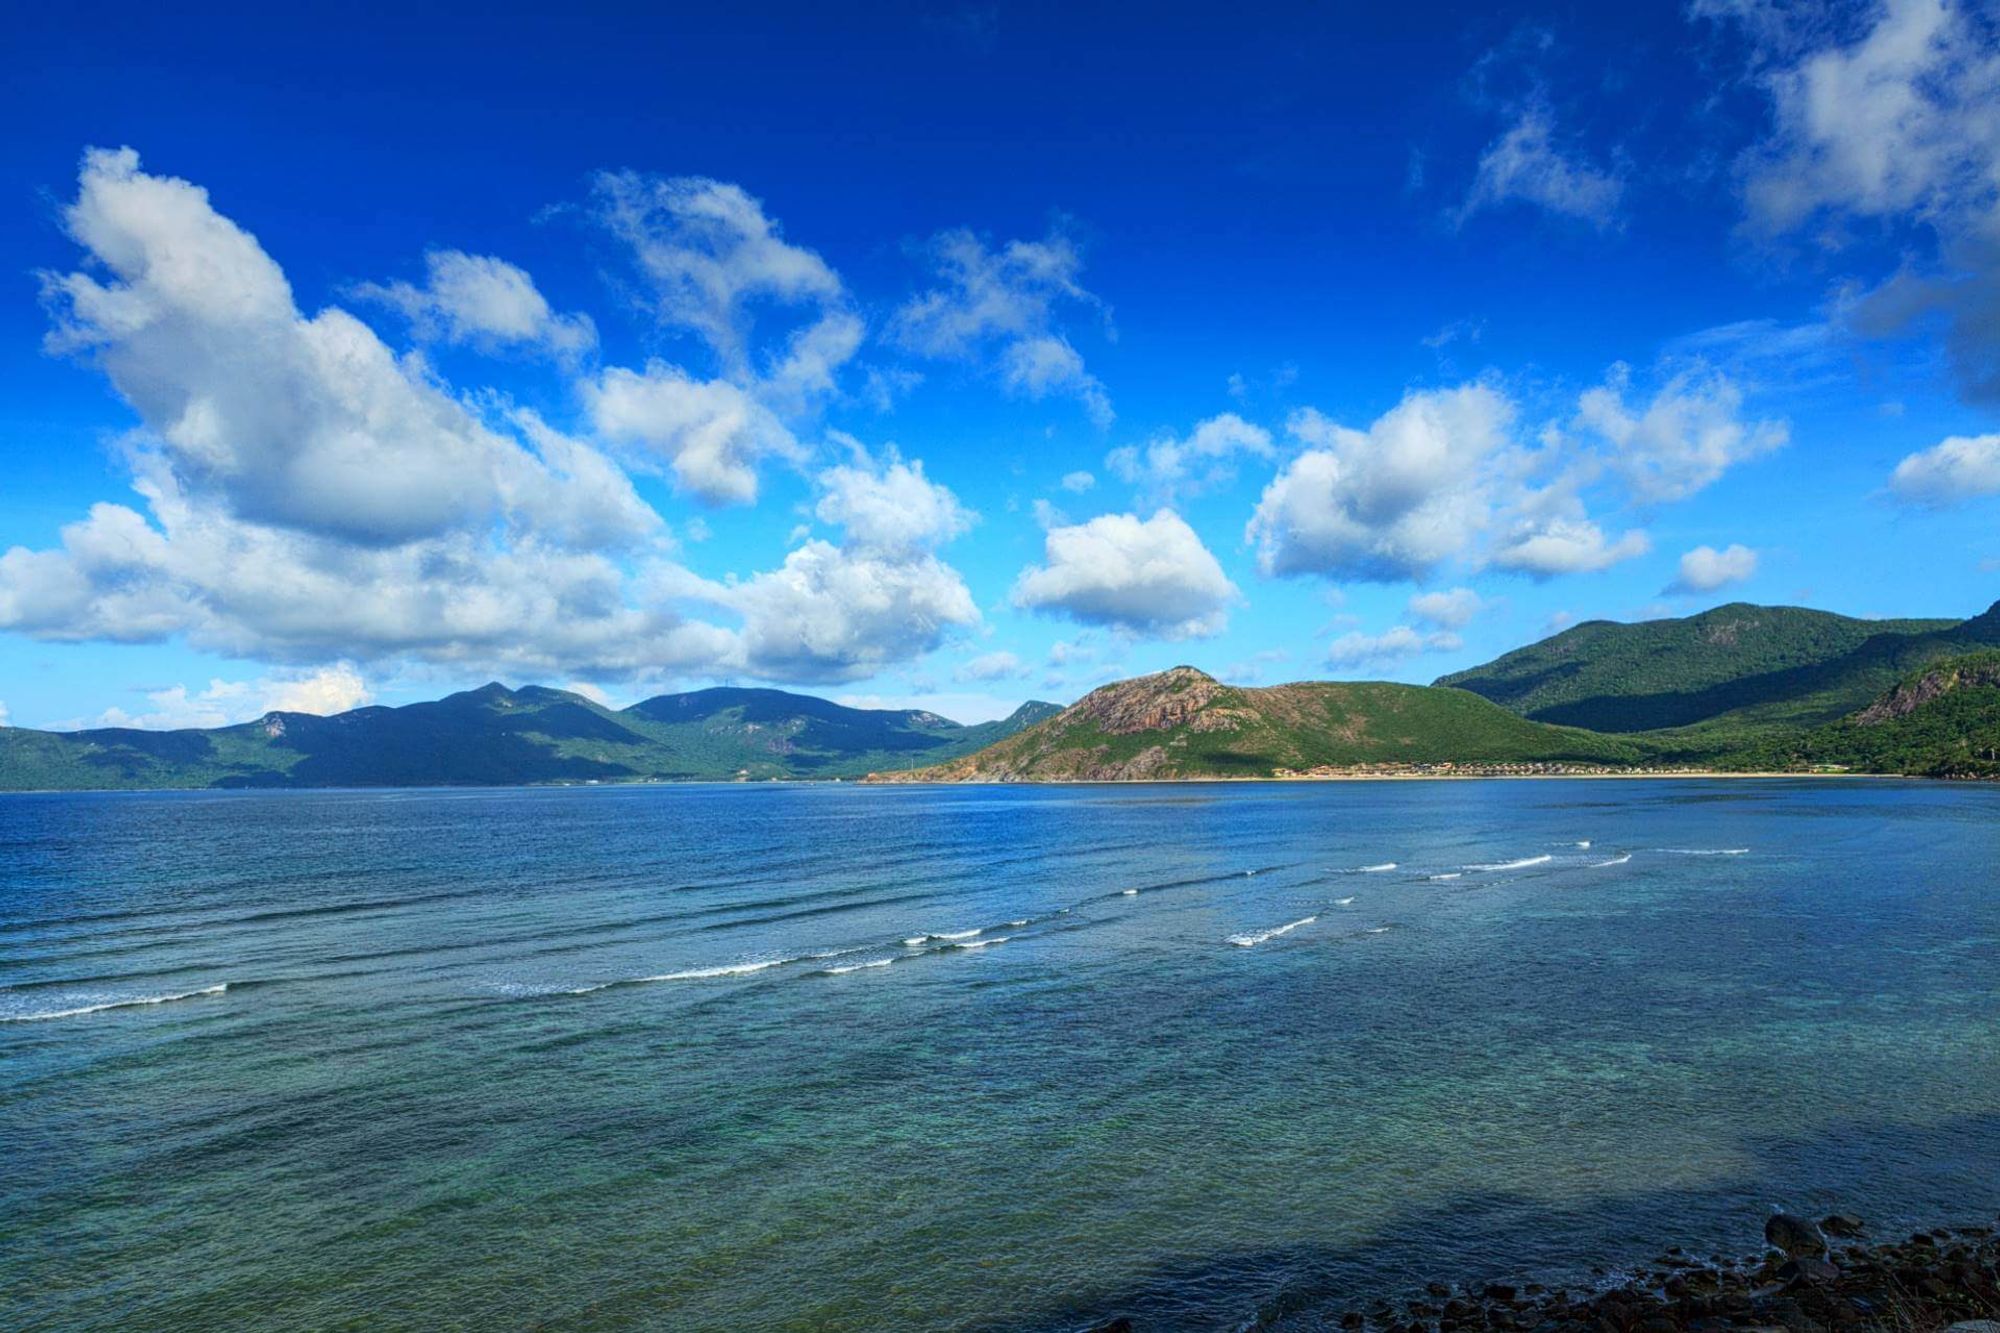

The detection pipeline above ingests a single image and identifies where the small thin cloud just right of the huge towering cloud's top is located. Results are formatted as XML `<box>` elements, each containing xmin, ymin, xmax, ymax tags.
<box><xmin>356</xmin><ymin>250</ymin><xmax>598</xmax><ymax>360</ymax></box>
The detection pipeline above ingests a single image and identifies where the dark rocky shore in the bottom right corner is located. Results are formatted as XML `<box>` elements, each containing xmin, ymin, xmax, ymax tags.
<box><xmin>1090</xmin><ymin>1213</ymin><xmax>2000</xmax><ymax>1333</ymax></box>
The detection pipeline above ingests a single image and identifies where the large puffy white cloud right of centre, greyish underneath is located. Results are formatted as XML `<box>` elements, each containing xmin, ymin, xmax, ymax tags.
<box><xmin>1246</xmin><ymin>384</ymin><xmax>1514</xmax><ymax>582</ymax></box>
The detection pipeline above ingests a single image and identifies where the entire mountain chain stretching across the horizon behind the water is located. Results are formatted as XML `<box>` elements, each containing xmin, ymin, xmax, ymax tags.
<box><xmin>0</xmin><ymin>602</ymin><xmax>2000</xmax><ymax>791</ymax></box>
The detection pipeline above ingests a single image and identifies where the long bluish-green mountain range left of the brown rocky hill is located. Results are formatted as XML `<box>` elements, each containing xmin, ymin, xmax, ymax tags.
<box><xmin>0</xmin><ymin>685</ymin><xmax>1058</xmax><ymax>791</ymax></box>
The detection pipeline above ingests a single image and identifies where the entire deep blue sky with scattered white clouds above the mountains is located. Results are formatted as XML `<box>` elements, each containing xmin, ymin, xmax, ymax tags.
<box><xmin>0</xmin><ymin>0</ymin><xmax>2000</xmax><ymax>729</ymax></box>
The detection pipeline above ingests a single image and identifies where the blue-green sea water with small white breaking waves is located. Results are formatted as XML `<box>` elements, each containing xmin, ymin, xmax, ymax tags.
<box><xmin>0</xmin><ymin>781</ymin><xmax>2000</xmax><ymax>1329</ymax></box>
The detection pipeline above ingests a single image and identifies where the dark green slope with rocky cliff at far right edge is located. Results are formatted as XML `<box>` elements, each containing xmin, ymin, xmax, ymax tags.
<box><xmin>1762</xmin><ymin>652</ymin><xmax>2000</xmax><ymax>779</ymax></box>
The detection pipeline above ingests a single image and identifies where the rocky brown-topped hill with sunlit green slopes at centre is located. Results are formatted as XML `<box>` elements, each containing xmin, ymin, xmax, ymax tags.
<box><xmin>876</xmin><ymin>667</ymin><xmax>1644</xmax><ymax>783</ymax></box>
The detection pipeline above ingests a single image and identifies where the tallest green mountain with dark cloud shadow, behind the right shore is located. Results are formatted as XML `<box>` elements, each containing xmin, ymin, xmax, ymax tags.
<box><xmin>1438</xmin><ymin>602</ymin><xmax>2000</xmax><ymax>757</ymax></box>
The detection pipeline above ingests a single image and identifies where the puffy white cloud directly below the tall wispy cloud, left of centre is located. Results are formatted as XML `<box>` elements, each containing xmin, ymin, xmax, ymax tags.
<box><xmin>582</xmin><ymin>360</ymin><xmax>804</xmax><ymax>504</ymax></box>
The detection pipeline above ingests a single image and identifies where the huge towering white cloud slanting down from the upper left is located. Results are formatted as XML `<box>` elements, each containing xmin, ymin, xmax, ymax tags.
<box><xmin>44</xmin><ymin>150</ymin><xmax>636</xmax><ymax>544</ymax></box>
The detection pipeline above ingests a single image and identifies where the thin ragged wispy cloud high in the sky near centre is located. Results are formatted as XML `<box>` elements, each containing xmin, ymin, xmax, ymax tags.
<box><xmin>890</xmin><ymin>230</ymin><xmax>1112</xmax><ymax>426</ymax></box>
